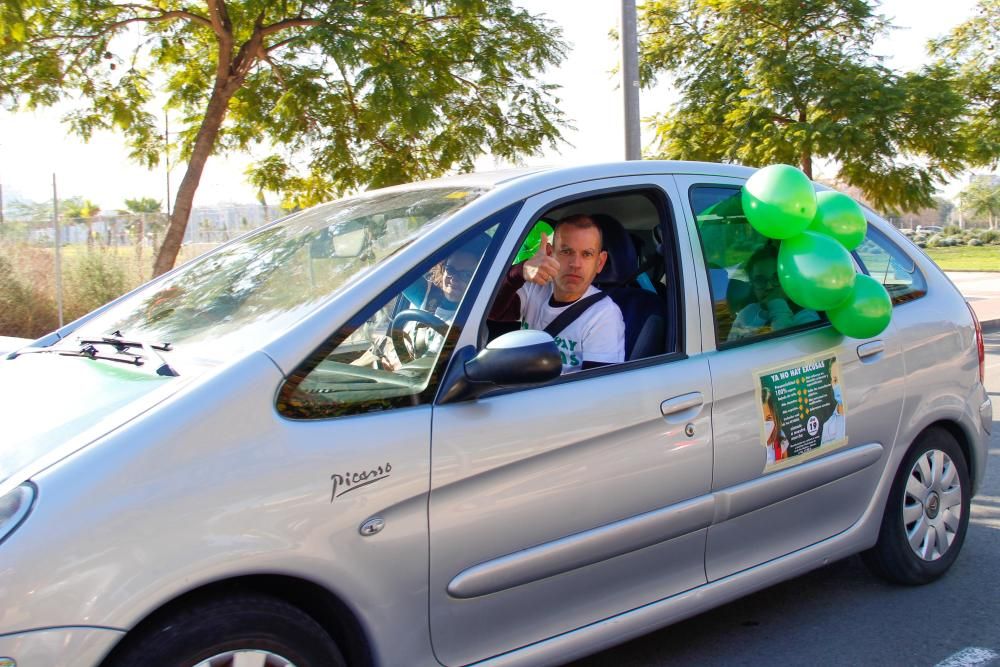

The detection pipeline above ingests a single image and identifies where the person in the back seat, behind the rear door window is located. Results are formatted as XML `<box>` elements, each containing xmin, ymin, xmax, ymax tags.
<box><xmin>727</xmin><ymin>243</ymin><xmax>819</xmax><ymax>341</ymax></box>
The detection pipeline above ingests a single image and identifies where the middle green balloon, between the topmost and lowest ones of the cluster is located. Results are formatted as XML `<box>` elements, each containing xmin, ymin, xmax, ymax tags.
<box><xmin>778</xmin><ymin>232</ymin><xmax>857</xmax><ymax>310</ymax></box>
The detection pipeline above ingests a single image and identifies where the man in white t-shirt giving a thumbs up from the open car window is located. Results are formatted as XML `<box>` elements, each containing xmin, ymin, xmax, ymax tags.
<box><xmin>493</xmin><ymin>215</ymin><xmax>625</xmax><ymax>373</ymax></box>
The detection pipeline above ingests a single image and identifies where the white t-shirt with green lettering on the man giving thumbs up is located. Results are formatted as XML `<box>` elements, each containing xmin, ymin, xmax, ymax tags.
<box><xmin>517</xmin><ymin>282</ymin><xmax>625</xmax><ymax>373</ymax></box>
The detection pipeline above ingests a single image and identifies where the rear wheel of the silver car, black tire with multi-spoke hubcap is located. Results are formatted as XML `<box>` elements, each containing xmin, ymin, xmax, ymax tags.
<box><xmin>861</xmin><ymin>428</ymin><xmax>972</xmax><ymax>586</ymax></box>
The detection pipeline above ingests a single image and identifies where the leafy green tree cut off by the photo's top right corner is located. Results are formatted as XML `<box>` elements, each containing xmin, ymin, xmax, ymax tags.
<box><xmin>929</xmin><ymin>0</ymin><xmax>1000</xmax><ymax>167</ymax></box>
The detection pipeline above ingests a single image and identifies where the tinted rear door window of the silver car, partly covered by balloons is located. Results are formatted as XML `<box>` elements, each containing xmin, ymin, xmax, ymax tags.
<box><xmin>690</xmin><ymin>185</ymin><xmax>822</xmax><ymax>343</ymax></box>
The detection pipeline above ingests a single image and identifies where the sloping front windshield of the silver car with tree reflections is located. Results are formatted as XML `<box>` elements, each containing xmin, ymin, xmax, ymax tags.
<box><xmin>69</xmin><ymin>187</ymin><xmax>483</xmax><ymax>361</ymax></box>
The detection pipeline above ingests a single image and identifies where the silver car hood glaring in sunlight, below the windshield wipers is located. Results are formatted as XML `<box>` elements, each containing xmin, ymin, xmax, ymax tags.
<box><xmin>0</xmin><ymin>352</ymin><xmax>182</xmax><ymax>487</ymax></box>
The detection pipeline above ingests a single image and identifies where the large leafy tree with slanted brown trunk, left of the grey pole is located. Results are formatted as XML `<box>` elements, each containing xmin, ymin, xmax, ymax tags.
<box><xmin>0</xmin><ymin>0</ymin><xmax>565</xmax><ymax>275</ymax></box>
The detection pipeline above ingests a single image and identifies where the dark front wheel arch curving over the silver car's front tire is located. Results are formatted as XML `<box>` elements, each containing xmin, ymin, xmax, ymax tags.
<box><xmin>101</xmin><ymin>574</ymin><xmax>374</xmax><ymax>667</ymax></box>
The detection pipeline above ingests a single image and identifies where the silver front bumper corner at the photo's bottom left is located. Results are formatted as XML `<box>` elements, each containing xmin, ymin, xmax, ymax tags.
<box><xmin>0</xmin><ymin>627</ymin><xmax>125</xmax><ymax>667</ymax></box>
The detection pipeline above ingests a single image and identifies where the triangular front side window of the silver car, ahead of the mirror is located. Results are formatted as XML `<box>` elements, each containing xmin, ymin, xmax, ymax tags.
<box><xmin>278</xmin><ymin>227</ymin><xmax>496</xmax><ymax>419</ymax></box>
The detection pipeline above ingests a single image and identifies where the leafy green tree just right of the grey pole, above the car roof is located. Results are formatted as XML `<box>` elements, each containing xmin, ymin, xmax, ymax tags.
<box><xmin>640</xmin><ymin>0</ymin><xmax>964</xmax><ymax>211</ymax></box>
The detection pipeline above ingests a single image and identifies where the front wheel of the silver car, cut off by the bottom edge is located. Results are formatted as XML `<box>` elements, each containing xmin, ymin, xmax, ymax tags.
<box><xmin>105</xmin><ymin>594</ymin><xmax>347</xmax><ymax>667</ymax></box>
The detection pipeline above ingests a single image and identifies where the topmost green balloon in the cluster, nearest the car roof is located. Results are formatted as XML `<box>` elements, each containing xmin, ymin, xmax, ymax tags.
<box><xmin>741</xmin><ymin>164</ymin><xmax>816</xmax><ymax>239</ymax></box>
